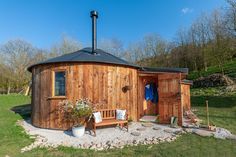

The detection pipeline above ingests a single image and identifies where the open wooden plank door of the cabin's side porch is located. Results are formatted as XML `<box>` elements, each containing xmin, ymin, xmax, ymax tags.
<box><xmin>158</xmin><ymin>73</ymin><xmax>182</xmax><ymax>125</ymax></box>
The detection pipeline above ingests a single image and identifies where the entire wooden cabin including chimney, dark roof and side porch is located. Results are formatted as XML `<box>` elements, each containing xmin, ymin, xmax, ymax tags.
<box><xmin>28</xmin><ymin>10</ymin><xmax>190</xmax><ymax>129</ymax></box>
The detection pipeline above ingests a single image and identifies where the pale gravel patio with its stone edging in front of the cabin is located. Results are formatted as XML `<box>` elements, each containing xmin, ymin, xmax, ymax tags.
<box><xmin>19</xmin><ymin>121</ymin><xmax>183</xmax><ymax>152</ymax></box>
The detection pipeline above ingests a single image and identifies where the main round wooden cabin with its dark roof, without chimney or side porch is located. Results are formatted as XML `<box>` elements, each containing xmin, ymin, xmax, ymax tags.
<box><xmin>29</xmin><ymin>48</ymin><xmax>139</xmax><ymax>129</ymax></box>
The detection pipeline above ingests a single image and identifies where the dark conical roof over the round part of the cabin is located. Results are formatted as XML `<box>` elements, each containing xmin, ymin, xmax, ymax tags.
<box><xmin>28</xmin><ymin>48</ymin><xmax>140</xmax><ymax>71</ymax></box>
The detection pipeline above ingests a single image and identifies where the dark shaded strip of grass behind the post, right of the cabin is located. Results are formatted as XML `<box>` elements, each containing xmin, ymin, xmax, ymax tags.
<box><xmin>191</xmin><ymin>96</ymin><xmax>236</xmax><ymax>108</ymax></box>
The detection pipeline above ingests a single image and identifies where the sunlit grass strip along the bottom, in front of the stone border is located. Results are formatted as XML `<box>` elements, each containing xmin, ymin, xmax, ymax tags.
<box><xmin>17</xmin><ymin>134</ymin><xmax>236</xmax><ymax>157</ymax></box>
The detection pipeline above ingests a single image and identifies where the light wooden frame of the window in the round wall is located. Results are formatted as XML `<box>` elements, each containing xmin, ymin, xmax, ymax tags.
<box><xmin>52</xmin><ymin>69</ymin><xmax>67</xmax><ymax>98</ymax></box>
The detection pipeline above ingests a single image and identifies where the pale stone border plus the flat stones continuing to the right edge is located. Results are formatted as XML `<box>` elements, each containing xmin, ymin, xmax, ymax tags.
<box><xmin>17</xmin><ymin>120</ymin><xmax>236</xmax><ymax>153</ymax></box>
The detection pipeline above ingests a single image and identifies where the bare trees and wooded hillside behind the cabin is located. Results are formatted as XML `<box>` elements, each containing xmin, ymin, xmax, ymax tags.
<box><xmin>0</xmin><ymin>0</ymin><xmax>236</xmax><ymax>94</ymax></box>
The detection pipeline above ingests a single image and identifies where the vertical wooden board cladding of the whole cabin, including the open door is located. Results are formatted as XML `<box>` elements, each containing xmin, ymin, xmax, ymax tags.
<box><xmin>31</xmin><ymin>63</ymin><xmax>190</xmax><ymax>130</ymax></box>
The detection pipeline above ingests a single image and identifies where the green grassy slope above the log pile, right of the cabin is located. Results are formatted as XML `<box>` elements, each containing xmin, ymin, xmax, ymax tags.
<box><xmin>188</xmin><ymin>59</ymin><xmax>236</xmax><ymax>80</ymax></box>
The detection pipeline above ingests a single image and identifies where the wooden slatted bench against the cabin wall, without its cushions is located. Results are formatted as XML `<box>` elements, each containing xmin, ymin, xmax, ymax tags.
<box><xmin>93</xmin><ymin>109</ymin><xmax>128</xmax><ymax>136</ymax></box>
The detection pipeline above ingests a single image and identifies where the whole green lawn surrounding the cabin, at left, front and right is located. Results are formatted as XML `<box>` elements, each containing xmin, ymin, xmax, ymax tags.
<box><xmin>0</xmin><ymin>94</ymin><xmax>236</xmax><ymax>157</ymax></box>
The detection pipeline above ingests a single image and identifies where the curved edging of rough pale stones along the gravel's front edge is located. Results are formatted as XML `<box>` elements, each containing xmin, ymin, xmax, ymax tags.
<box><xmin>17</xmin><ymin>121</ymin><xmax>185</xmax><ymax>153</ymax></box>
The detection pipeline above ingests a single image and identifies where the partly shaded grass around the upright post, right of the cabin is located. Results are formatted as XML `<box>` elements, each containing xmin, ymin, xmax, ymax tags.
<box><xmin>191</xmin><ymin>87</ymin><xmax>236</xmax><ymax>134</ymax></box>
